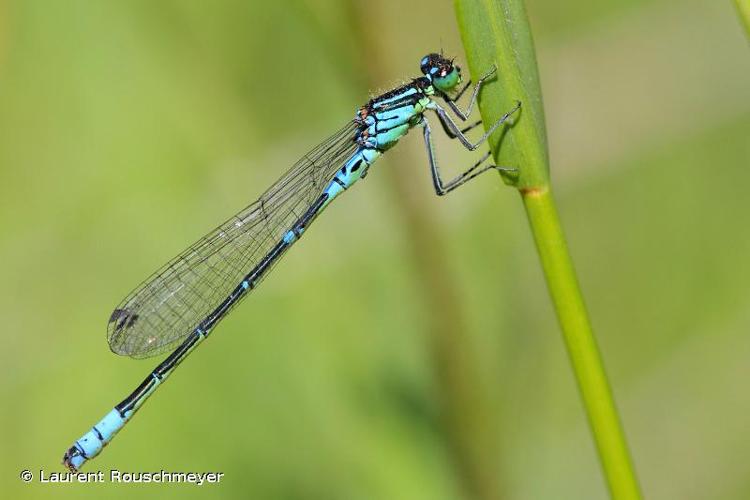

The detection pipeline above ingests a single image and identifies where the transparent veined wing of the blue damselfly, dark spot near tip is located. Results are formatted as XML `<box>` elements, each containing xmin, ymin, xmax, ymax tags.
<box><xmin>107</xmin><ymin>122</ymin><xmax>357</xmax><ymax>358</ymax></box>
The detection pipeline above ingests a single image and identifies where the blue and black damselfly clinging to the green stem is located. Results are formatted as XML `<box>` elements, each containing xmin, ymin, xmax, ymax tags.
<box><xmin>63</xmin><ymin>54</ymin><xmax>521</xmax><ymax>471</ymax></box>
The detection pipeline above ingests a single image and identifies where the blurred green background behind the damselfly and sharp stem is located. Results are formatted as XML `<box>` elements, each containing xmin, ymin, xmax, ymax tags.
<box><xmin>0</xmin><ymin>0</ymin><xmax>750</xmax><ymax>500</ymax></box>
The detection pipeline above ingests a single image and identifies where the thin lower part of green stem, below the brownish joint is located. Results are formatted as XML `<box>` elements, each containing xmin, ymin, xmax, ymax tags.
<box><xmin>521</xmin><ymin>188</ymin><xmax>641</xmax><ymax>500</ymax></box>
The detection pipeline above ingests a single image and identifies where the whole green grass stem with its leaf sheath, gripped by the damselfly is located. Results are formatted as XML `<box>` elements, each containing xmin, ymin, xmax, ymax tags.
<box><xmin>456</xmin><ymin>0</ymin><xmax>641</xmax><ymax>500</ymax></box>
